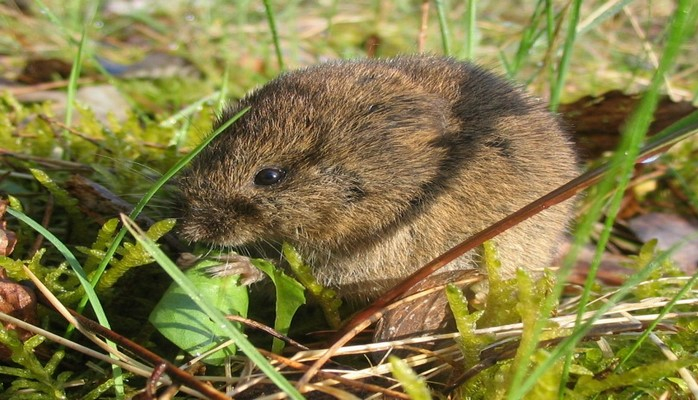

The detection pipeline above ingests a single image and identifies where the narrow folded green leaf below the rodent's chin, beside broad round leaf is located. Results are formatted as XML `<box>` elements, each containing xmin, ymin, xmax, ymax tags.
<box><xmin>250</xmin><ymin>259</ymin><xmax>305</xmax><ymax>353</ymax></box>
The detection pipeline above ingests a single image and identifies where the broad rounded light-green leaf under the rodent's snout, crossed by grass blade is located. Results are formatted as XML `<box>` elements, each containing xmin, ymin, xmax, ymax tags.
<box><xmin>149</xmin><ymin>260</ymin><xmax>249</xmax><ymax>365</ymax></box>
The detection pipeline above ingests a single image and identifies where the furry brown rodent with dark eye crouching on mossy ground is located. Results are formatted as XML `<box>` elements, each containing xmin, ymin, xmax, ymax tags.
<box><xmin>178</xmin><ymin>55</ymin><xmax>577</xmax><ymax>301</ymax></box>
